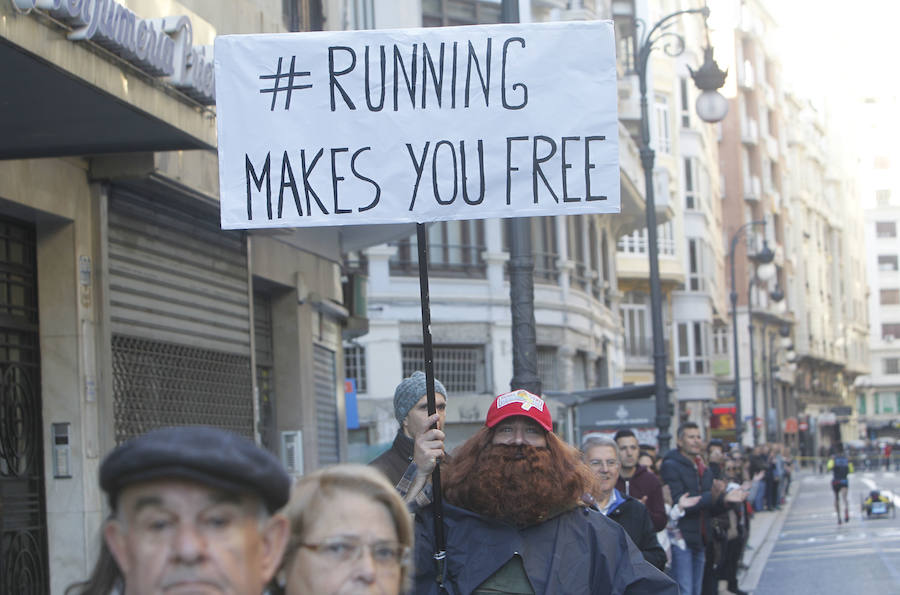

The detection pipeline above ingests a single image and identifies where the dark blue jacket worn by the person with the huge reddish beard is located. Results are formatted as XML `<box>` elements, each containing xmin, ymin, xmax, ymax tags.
<box><xmin>413</xmin><ymin>502</ymin><xmax>678</xmax><ymax>595</ymax></box>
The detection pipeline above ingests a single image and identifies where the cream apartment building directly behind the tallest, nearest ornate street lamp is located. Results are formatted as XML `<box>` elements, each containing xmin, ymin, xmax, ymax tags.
<box><xmin>612</xmin><ymin>1</ymin><xmax>730</xmax><ymax>436</ymax></box>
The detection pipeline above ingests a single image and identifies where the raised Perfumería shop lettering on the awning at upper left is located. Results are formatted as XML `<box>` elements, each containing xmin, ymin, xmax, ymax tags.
<box><xmin>12</xmin><ymin>0</ymin><xmax>216</xmax><ymax>105</ymax></box>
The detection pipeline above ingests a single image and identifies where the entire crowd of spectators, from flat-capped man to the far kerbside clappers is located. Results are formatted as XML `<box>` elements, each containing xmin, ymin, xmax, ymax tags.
<box><xmin>69</xmin><ymin>372</ymin><xmax>808</xmax><ymax>595</ymax></box>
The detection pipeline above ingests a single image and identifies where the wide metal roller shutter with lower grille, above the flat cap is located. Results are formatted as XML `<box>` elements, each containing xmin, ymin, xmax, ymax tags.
<box><xmin>108</xmin><ymin>189</ymin><xmax>254</xmax><ymax>442</ymax></box>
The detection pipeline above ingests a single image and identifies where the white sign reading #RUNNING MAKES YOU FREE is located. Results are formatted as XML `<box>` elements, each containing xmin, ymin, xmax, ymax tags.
<box><xmin>215</xmin><ymin>21</ymin><xmax>620</xmax><ymax>229</ymax></box>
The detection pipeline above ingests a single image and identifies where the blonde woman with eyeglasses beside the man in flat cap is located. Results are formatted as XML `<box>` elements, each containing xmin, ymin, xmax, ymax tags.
<box><xmin>276</xmin><ymin>464</ymin><xmax>413</xmax><ymax>595</ymax></box>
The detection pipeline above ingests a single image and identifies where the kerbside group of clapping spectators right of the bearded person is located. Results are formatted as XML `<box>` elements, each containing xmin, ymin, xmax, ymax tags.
<box><xmin>582</xmin><ymin>423</ymin><xmax>794</xmax><ymax>595</ymax></box>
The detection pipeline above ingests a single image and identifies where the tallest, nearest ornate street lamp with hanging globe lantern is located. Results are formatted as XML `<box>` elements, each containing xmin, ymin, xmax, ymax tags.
<box><xmin>633</xmin><ymin>7</ymin><xmax>728</xmax><ymax>452</ymax></box>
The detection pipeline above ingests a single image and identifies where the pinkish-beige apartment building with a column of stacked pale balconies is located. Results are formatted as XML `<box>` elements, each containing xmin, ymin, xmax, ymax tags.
<box><xmin>711</xmin><ymin>0</ymin><xmax>797</xmax><ymax>444</ymax></box>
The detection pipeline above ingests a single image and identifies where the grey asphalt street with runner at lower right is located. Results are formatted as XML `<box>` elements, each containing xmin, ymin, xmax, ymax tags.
<box><xmin>743</xmin><ymin>471</ymin><xmax>900</xmax><ymax>595</ymax></box>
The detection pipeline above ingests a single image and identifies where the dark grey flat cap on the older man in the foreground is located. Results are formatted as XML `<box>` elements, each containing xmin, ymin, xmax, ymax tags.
<box><xmin>100</xmin><ymin>426</ymin><xmax>291</xmax><ymax>512</ymax></box>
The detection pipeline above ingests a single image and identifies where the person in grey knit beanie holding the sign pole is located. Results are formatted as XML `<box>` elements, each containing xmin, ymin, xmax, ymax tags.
<box><xmin>369</xmin><ymin>371</ymin><xmax>447</xmax><ymax>485</ymax></box>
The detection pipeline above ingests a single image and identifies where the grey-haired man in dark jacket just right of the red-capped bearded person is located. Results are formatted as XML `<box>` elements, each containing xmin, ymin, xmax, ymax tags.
<box><xmin>581</xmin><ymin>434</ymin><xmax>666</xmax><ymax>570</ymax></box>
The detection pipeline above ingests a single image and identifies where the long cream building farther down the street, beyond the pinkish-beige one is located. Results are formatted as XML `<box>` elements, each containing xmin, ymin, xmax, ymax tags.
<box><xmin>785</xmin><ymin>96</ymin><xmax>868</xmax><ymax>454</ymax></box>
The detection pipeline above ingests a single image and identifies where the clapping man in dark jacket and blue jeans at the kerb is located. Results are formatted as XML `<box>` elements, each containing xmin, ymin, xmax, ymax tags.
<box><xmin>660</xmin><ymin>422</ymin><xmax>743</xmax><ymax>595</ymax></box>
